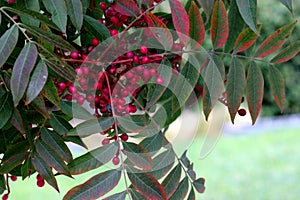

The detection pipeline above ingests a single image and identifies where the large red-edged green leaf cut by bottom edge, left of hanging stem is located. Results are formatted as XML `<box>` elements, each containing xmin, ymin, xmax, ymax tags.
<box><xmin>63</xmin><ymin>170</ymin><xmax>121</xmax><ymax>200</ymax></box>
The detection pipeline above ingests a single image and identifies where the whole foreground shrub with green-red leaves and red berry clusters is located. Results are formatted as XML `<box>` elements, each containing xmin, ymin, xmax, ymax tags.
<box><xmin>0</xmin><ymin>0</ymin><xmax>300</xmax><ymax>199</ymax></box>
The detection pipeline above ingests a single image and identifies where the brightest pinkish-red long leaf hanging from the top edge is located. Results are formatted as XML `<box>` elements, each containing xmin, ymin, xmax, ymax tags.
<box><xmin>169</xmin><ymin>0</ymin><xmax>190</xmax><ymax>44</ymax></box>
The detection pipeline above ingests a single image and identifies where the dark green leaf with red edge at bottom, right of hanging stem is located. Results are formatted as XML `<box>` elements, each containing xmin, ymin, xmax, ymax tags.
<box><xmin>127</xmin><ymin>172</ymin><xmax>167</xmax><ymax>200</ymax></box>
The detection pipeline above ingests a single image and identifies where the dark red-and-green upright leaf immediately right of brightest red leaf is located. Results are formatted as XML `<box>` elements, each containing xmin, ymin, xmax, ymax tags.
<box><xmin>189</xmin><ymin>1</ymin><xmax>205</xmax><ymax>46</ymax></box>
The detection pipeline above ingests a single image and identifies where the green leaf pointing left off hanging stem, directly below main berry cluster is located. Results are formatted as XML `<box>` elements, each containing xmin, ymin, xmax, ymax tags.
<box><xmin>67</xmin><ymin>117</ymin><xmax>114</xmax><ymax>137</ymax></box>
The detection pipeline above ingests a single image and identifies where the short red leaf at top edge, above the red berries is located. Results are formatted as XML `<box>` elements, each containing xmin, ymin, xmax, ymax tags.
<box><xmin>111</xmin><ymin>0</ymin><xmax>139</xmax><ymax>16</ymax></box>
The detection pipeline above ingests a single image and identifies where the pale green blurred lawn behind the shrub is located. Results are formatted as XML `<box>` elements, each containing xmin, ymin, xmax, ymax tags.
<box><xmin>10</xmin><ymin>127</ymin><xmax>300</xmax><ymax>200</ymax></box>
